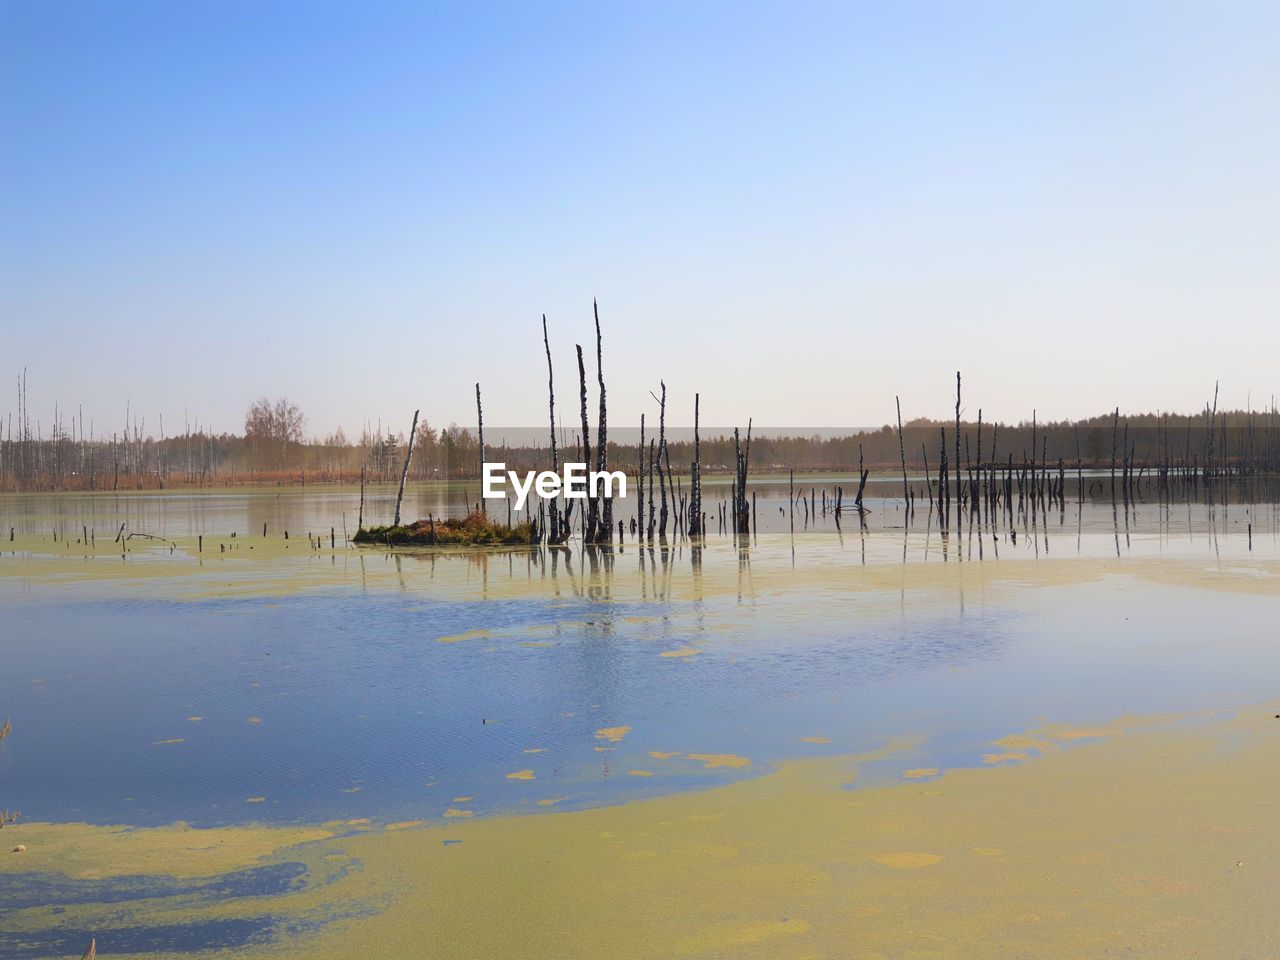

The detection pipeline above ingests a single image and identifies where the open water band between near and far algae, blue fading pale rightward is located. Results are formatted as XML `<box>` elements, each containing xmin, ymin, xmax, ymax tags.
<box><xmin>0</xmin><ymin>580</ymin><xmax>1280</xmax><ymax>826</ymax></box>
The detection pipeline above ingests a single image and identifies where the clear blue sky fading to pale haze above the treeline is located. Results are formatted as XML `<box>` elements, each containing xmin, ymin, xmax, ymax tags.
<box><xmin>0</xmin><ymin>0</ymin><xmax>1280</xmax><ymax>434</ymax></box>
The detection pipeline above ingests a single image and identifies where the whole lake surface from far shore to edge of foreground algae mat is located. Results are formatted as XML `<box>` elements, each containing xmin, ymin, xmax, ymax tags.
<box><xmin>0</xmin><ymin>480</ymin><xmax>1280</xmax><ymax>826</ymax></box>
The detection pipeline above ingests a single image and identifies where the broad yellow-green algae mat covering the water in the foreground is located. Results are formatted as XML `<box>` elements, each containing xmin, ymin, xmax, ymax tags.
<box><xmin>10</xmin><ymin>705</ymin><xmax>1280</xmax><ymax>960</ymax></box>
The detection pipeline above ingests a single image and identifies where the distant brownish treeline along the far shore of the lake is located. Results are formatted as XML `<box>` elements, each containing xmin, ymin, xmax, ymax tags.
<box><xmin>0</xmin><ymin>401</ymin><xmax>1280</xmax><ymax>492</ymax></box>
